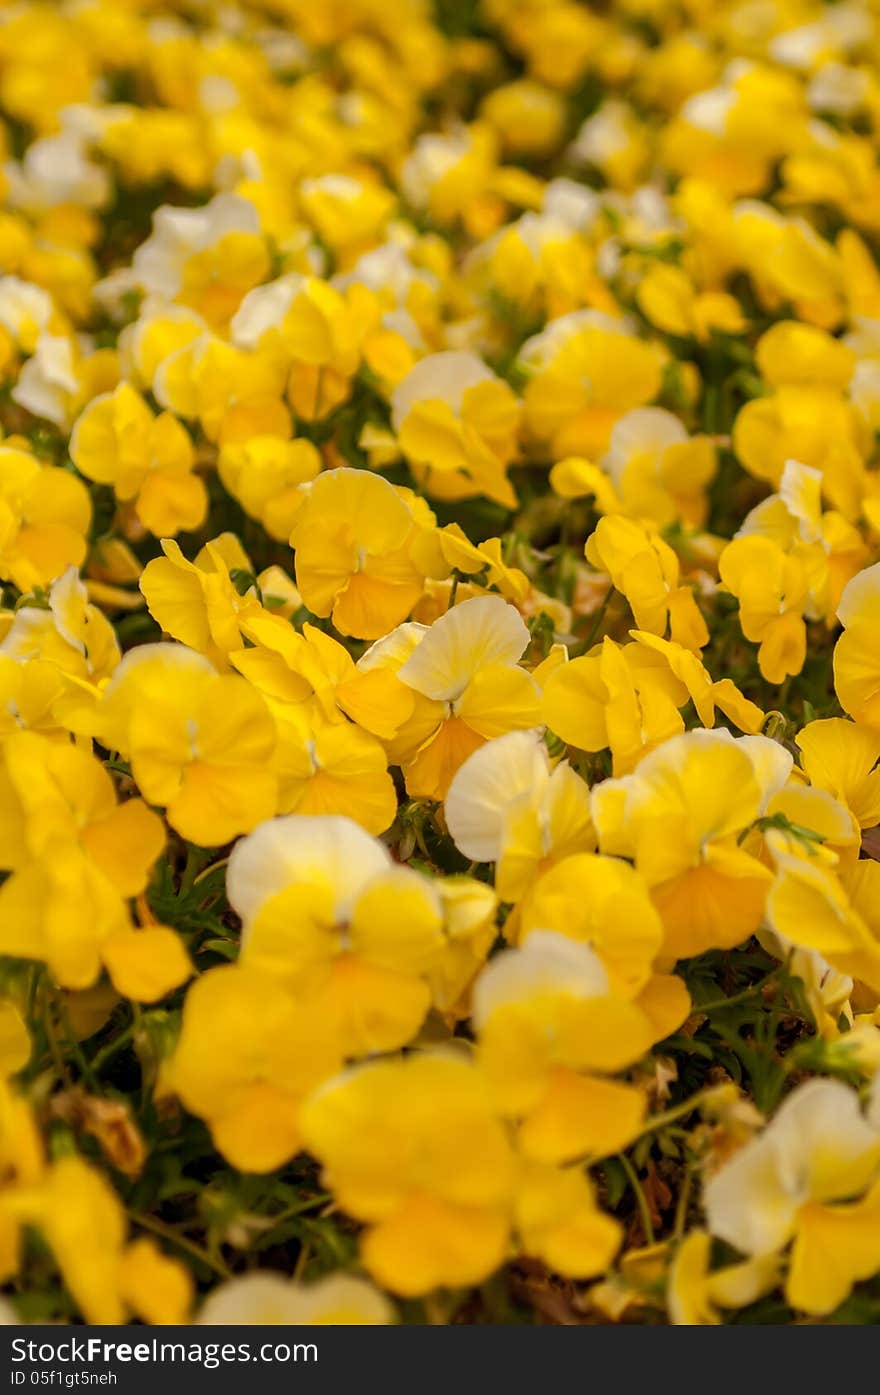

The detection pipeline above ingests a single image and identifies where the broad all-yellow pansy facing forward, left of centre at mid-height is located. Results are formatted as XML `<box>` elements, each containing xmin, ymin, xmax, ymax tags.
<box><xmin>95</xmin><ymin>644</ymin><xmax>278</xmax><ymax>847</ymax></box>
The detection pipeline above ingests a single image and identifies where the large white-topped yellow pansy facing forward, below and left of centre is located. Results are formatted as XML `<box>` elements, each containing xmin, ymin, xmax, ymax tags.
<box><xmin>227</xmin><ymin>813</ymin><xmax>445</xmax><ymax>1055</ymax></box>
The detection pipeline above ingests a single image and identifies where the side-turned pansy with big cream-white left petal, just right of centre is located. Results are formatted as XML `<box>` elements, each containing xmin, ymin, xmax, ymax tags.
<box><xmin>443</xmin><ymin>731</ymin><xmax>595</xmax><ymax>901</ymax></box>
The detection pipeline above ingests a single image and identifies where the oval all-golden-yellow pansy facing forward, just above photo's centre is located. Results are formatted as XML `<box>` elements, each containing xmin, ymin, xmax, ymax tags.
<box><xmin>291</xmin><ymin>469</ymin><xmax>424</xmax><ymax>639</ymax></box>
